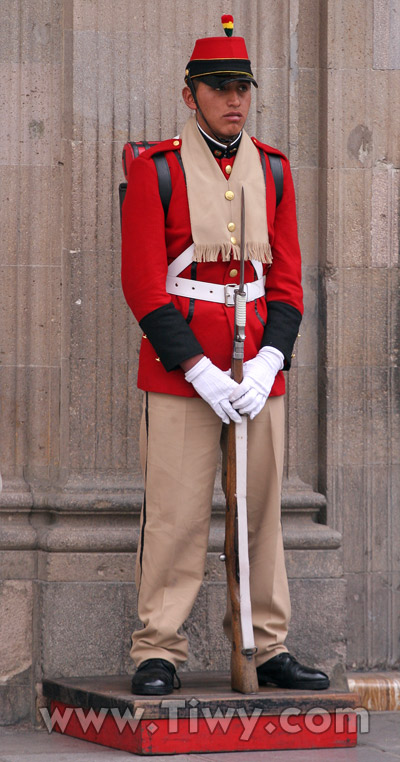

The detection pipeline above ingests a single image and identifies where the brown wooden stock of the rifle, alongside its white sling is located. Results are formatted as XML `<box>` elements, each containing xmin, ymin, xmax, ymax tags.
<box><xmin>225</xmin><ymin>358</ymin><xmax>258</xmax><ymax>693</ymax></box>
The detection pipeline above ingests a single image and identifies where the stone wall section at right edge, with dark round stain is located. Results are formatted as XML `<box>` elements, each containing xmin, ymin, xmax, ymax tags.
<box><xmin>319</xmin><ymin>0</ymin><xmax>400</xmax><ymax>669</ymax></box>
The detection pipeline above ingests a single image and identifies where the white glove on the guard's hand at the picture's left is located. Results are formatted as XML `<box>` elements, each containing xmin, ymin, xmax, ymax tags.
<box><xmin>185</xmin><ymin>357</ymin><xmax>242</xmax><ymax>423</ymax></box>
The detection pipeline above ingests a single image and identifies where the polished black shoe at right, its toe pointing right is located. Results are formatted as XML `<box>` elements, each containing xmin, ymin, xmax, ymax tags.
<box><xmin>257</xmin><ymin>652</ymin><xmax>329</xmax><ymax>691</ymax></box>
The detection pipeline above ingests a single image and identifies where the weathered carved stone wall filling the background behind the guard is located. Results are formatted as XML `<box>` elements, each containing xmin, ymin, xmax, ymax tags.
<box><xmin>0</xmin><ymin>0</ymin><xmax>400</xmax><ymax>723</ymax></box>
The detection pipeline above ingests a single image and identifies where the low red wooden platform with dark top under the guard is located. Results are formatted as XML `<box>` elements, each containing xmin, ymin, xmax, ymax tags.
<box><xmin>41</xmin><ymin>672</ymin><xmax>359</xmax><ymax>755</ymax></box>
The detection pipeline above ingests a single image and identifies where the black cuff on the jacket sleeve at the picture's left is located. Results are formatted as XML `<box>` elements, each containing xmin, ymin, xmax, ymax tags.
<box><xmin>139</xmin><ymin>302</ymin><xmax>203</xmax><ymax>371</ymax></box>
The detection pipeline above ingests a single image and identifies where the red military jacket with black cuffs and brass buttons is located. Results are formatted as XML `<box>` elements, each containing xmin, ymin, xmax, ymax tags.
<box><xmin>122</xmin><ymin>138</ymin><xmax>303</xmax><ymax>397</ymax></box>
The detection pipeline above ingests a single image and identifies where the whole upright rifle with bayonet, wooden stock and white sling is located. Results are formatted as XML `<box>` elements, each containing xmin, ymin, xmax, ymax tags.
<box><xmin>223</xmin><ymin>188</ymin><xmax>258</xmax><ymax>693</ymax></box>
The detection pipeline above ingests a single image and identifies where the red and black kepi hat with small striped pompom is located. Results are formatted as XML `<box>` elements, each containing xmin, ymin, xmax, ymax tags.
<box><xmin>185</xmin><ymin>14</ymin><xmax>258</xmax><ymax>87</ymax></box>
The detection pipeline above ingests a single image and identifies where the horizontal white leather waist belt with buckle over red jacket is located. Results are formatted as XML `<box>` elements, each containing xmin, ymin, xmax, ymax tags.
<box><xmin>166</xmin><ymin>275</ymin><xmax>265</xmax><ymax>307</ymax></box>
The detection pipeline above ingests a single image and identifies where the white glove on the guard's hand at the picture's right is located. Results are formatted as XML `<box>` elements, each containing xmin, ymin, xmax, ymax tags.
<box><xmin>229</xmin><ymin>347</ymin><xmax>285</xmax><ymax>420</ymax></box>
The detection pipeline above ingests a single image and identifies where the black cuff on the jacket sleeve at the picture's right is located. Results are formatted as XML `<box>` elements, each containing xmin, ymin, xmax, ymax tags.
<box><xmin>261</xmin><ymin>302</ymin><xmax>301</xmax><ymax>370</ymax></box>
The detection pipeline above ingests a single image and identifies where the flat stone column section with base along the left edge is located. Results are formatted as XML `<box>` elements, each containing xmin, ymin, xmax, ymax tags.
<box><xmin>0</xmin><ymin>0</ymin><xmax>64</xmax><ymax>723</ymax></box>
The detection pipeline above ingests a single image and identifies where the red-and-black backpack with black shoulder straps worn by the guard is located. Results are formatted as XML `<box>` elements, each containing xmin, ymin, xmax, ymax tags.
<box><xmin>119</xmin><ymin>140</ymin><xmax>283</xmax><ymax>221</ymax></box>
